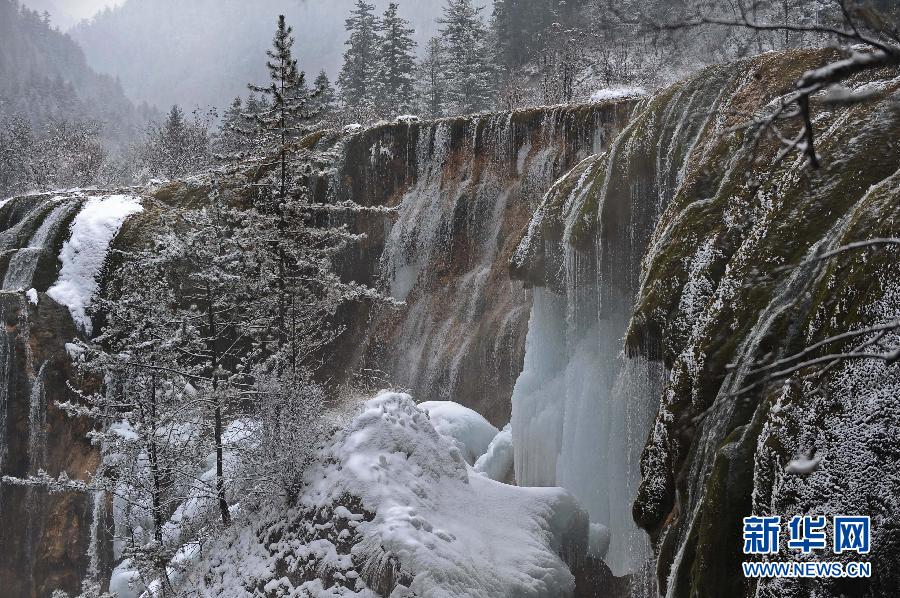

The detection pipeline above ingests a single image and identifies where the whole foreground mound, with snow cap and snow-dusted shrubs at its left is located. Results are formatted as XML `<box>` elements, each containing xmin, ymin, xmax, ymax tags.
<box><xmin>191</xmin><ymin>393</ymin><xmax>588</xmax><ymax>598</ymax></box>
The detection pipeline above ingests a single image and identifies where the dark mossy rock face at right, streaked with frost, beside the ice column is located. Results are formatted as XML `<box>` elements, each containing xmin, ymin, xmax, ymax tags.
<box><xmin>626</xmin><ymin>52</ymin><xmax>900</xmax><ymax>596</ymax></box>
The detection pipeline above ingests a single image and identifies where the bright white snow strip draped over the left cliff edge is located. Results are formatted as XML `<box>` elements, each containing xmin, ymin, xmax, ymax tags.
<box><xmin>47</xmin><ymin>195</ymin><xmax>143</xmax><ymax>335</ymax></box>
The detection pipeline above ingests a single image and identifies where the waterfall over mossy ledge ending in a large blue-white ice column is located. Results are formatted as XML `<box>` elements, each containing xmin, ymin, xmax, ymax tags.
<box><xmin>511</xmin><ymin>64</ymin><xmax>736</xmax><ymax>584</ymax></box>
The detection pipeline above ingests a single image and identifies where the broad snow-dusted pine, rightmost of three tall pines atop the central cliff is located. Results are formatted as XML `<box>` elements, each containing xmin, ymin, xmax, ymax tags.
<box><xmin>438</xmin><ymin>0</ymin><xmax>492</xmax><ymax>114</ymax></box>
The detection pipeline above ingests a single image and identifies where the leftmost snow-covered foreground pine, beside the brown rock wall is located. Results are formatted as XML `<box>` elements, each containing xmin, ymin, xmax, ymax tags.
<box><xmin>58</xmin><ymin>245</ymin><xmax>212</xmax><ymax>596</ymax></box>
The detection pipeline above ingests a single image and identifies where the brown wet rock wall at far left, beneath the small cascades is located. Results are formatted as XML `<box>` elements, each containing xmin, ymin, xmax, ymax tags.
<box><xmin>0</xmin><ymin>292</ymin><xmax>108</xmax><ymax>597</ymax></box>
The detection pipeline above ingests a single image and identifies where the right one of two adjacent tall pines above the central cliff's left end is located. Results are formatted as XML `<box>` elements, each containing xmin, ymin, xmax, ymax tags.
<box><xmin>376</xmin><ymin>2</ymin><xmax>416</xmax><ymax>114</ymax></box>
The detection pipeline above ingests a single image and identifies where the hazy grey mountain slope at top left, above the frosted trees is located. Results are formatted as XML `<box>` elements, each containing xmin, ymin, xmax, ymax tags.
<box><xmin>0</xmin><ymin>0</ymin><xmax>147</xmax><ymax>141</ymax></box>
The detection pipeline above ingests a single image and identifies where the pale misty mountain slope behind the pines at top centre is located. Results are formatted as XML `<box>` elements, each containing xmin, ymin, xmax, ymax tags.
<box><xmin>70</xmin><ymin>0</ymin><xmax>443</xmax><ymax>107</ymax></box>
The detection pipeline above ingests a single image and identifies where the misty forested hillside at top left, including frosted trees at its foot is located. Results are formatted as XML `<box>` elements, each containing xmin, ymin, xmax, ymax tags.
<box><xmin>0</xmin><ymin>0</ymin><xmax>152</xmax><ymax>197</ymax></box>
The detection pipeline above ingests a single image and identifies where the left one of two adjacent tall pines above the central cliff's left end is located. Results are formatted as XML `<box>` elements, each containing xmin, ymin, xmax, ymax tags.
<box><xmin>338</xmin><ymin>0</ymin><xmax>379</xmax><ymax>110</ymax></box>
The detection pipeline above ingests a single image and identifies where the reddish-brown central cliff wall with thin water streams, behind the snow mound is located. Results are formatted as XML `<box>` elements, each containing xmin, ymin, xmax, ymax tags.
<box><xmin>330</xmin><ymin>101</ymin><xmax>634</xmax><ymax>426</ymax></box>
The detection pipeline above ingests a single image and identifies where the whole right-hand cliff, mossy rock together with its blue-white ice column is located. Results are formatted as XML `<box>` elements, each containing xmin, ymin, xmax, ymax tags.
<box><xmin>511</xmin><ymin>52</ymin><xmax>900</xmax><ymax>596</ymax></box>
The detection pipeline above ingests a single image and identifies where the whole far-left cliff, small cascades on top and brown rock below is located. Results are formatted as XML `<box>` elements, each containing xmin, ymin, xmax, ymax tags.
<box><xmin>0</xmin><ymin>197</ymin><xmax>109</xmax><ymax>596</ymax></box>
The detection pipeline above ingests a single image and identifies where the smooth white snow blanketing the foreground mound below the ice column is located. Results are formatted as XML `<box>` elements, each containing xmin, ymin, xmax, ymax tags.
<box><xmin>308</xmin><ymin>393</ymin><xmax>586</xmax><ymax>598</ymax></box>
